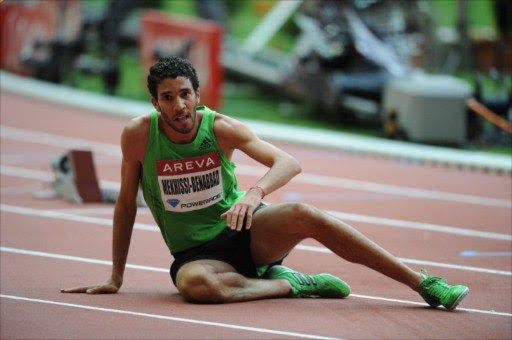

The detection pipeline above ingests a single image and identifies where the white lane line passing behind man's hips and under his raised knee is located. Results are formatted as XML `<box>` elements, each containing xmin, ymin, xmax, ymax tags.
<box><xmin>0</xmin><ymin>204</ymin><xmax>512</xmax><ymax>276</ymax></box>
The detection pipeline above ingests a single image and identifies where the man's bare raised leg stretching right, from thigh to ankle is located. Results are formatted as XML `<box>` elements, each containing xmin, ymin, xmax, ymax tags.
<box><xmin>251</xmin><ymin>203</ymin><xmax>423</xmax><ymax>291</ymax></box>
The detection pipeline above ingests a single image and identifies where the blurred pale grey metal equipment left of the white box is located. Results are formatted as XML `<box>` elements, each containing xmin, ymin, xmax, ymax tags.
<box><xmin>224</xmin><ymin>0</ymin><xmax>428</xmax><ymax>124</ymax></box>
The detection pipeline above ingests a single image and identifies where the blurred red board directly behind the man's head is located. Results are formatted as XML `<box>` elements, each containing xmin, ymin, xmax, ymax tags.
<box><xmin>140</xmin><ymin>10</ymin><xmax>223</xmax><ymax>108</ymax></box>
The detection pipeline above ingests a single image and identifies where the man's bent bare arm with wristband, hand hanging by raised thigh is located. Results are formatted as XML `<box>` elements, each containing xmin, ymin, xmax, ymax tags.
<box><xmin>215</xmin><ymin>116</ymin><xmax>301</xmax><ymax>231</ymax></box>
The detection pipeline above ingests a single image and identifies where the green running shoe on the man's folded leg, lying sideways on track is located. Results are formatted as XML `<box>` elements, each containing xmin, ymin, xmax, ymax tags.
<box><xmin>265</xmin><ymin>265</ymin><xmax>350</xmax><ymax>299</ymax></box>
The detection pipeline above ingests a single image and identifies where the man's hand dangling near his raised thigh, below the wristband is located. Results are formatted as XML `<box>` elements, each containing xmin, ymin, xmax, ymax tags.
<box><xmin>220</xmin><ymin>188</ymin><xmax>263</xmax><ymax>231</ymax></box>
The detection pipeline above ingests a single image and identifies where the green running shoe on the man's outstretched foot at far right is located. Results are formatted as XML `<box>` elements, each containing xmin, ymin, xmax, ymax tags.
<box><xmin>419</xmin><ymin>272</ymin><xmax>469</xmax><ymax>310</ymax></box>
